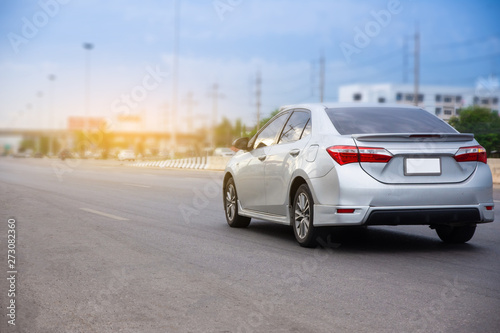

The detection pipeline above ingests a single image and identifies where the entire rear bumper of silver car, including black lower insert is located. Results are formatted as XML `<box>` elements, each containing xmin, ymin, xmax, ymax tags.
<box><xmin>308</xmin><ymin>164</ymin><xmax>494</xmax><ymax>226</ymax></box>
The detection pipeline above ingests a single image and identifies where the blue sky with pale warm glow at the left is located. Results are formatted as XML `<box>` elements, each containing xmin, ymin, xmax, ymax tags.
<box><xmin>0</xmin><ymin>0</ymin><xmax>500</xmax><ymax>130</ymax></box>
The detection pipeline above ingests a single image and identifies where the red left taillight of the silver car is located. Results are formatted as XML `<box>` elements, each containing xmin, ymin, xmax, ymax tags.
<box><xmin>326</xmin><ymin>146</ymin><xmax>392</xmax><ymax>165</ymax></box>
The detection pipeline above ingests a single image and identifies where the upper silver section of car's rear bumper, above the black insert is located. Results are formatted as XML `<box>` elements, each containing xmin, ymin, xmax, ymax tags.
<box><xmin>308</xmin><ymin>165</ymin><xmax>493</xmax><ymax>207</ymax></box>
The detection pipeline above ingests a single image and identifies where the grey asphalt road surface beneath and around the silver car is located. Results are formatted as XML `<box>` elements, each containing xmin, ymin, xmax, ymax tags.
<box><xmin>0</xmin><ymin>158</ymin><xmax>500</xmax><ymax>333</ymax></box>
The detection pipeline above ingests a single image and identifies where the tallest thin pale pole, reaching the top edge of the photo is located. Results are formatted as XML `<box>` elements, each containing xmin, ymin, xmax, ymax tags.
<box><xmin>171</xmin><ymin>0</ymin><xmax>180</xmax><ymax>157</ymax></box>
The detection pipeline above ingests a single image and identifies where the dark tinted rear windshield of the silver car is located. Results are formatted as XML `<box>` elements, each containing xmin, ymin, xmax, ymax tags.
<box><xmin>326</xmin><ymin>107</ymin><xmax>457</xmax><ymax>135</ymax></box>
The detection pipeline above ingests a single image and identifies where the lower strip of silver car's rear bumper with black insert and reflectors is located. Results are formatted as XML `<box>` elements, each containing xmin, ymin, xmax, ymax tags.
<box><xmin>314</xmin><ymin>203</ymin><xmax>494</xmax><ymax>227</ymax></box>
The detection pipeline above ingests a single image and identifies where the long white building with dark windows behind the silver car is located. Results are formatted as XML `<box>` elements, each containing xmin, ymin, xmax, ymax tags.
<box><xmin>339</xmin><ymin>79</ymin><xmax>500</xmax><ymax>120</ymax></box>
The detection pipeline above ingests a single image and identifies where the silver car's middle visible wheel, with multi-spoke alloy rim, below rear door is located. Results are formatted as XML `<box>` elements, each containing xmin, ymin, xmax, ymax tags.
<box><xmin>291</xmin><ymin>184</ymin><xmax>319</xmax><ymax>247</ymax></box>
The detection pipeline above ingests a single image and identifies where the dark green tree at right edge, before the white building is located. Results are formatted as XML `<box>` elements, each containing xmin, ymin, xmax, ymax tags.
<box><xmin>449</xmin><ymin>105</ymin><xmax>500</xmax><ymax>155</ymax></box>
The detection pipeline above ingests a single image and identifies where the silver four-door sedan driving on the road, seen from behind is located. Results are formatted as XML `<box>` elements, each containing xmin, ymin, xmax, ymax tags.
<box><xmin>223</xmin><ymin>104</ymin><xmax>494</xmax><ymax>247</ymax></box>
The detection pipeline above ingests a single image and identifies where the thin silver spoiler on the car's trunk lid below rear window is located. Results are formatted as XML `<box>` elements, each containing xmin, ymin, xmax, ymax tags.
<box><xmin>352</xmin><ymin>133</ymin><xmax>474</xmax><ymax>142</ymax></box>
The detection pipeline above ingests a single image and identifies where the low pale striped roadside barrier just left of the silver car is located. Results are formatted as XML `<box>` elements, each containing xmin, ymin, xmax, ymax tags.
<box><xmin>132</xmin><ymin>156</ymin><xmax>231</xmax><ymax>170</ymax></box>
